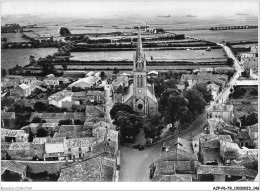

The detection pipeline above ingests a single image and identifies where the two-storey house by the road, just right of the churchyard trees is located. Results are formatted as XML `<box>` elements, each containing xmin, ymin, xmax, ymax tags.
<box><xmin>206</xmin><ymin>104</ymin><xmax>234</xmax><ymax>124</ymax></box>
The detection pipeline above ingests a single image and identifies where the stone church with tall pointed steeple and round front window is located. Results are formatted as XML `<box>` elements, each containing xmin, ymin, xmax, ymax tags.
<box><xmin>113</xmin><ymin>29</ymin><xmax>158</xmax><ymax>116</ymax></box>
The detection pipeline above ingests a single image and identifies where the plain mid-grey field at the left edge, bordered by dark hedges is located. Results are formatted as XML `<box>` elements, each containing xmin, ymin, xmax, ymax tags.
<box><xmin>1</xmin><ymin>48</ymin><xmax>57</xmax><ymax>69</ymax></box>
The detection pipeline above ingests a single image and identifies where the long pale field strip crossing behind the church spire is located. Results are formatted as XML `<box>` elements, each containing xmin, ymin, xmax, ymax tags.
<box><xmin>71</xmin><ymin>49</ymin><xmax>226</xmax><ymax>62</ymax></box>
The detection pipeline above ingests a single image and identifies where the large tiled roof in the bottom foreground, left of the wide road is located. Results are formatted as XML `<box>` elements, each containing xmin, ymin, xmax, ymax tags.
<box><xmin>58</xmin><ymin>156</ymin><xmax>116</xmax><ymax>182</ymax></box>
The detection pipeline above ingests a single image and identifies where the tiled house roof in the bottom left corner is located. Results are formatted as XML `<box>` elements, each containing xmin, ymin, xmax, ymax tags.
<box><xmin>1</xmin><ymin>160</ymin><xmax>27</xmax><ymax>174</ymax></box>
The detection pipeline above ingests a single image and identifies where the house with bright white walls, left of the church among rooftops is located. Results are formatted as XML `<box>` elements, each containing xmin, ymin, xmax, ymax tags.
<box><xmin>48</xmin><ymin>90</ymin><xmax>73</xmax><ymax>108</ymax></box>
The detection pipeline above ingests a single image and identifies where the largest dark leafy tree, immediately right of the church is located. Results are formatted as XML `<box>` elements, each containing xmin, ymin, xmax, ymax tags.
<box><xmin>159</xmin><ymin>88</ymin><xmax>189</xmax><ymax>130</ymax></box>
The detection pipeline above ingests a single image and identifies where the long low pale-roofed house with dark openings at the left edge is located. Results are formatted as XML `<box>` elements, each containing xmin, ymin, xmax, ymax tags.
<box><xmin>1</xmin><ymin>128</ymin><xmax>29</xmax><ymax>142</ymax></box>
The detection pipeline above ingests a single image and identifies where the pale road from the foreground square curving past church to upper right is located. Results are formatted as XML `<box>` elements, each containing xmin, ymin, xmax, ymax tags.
<box><xmin>119</xmin><ymin>44</ymin><xmax>244</xmax><ymax>182</ymax></box>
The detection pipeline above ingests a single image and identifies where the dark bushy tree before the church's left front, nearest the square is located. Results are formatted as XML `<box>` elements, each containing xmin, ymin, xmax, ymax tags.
<box><xmin>113</xmin><ymin>111</ymin><xmax>143</xmax><ymax>141</ymax></box>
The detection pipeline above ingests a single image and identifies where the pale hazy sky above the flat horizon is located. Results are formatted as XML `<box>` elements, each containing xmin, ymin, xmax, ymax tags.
<box><xmin>1</xmin><ymin>0</ymin><xmax>259</xmax><ymax>17</ymax></box>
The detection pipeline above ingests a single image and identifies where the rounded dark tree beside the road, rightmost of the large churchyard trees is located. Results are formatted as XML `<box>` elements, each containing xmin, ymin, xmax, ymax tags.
<box><xmin>184</xmin><ymin>89</ymin><xmax>206</xmax><ymax>118</ymax></box>
